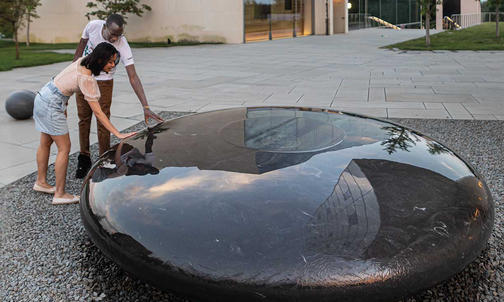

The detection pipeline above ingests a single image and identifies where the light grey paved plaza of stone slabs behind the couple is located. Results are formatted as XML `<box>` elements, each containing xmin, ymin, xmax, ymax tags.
<box><xmin>0</xmin><ymin>29</ymin><xmax>504</xmax><ymax>187</ymax></box>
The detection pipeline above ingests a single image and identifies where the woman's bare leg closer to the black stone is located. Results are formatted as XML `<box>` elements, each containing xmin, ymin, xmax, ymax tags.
<box><xmin>51</xmin><ymin>133</ymin><xmax>73</xmax><ymax>198</ymax></box>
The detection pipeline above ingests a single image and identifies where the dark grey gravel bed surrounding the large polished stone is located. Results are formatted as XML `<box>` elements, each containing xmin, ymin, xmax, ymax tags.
<box><xmin>0</xmin><ymin>112</ymin><xmax>504</xmax><ymax>302</ymax></box>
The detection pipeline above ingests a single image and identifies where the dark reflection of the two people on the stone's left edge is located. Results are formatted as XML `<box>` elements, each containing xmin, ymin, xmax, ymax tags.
<box><xmin>92</xmin><ymin>129</ymin><xmax>159</xmax><ymax>182</ymax></box>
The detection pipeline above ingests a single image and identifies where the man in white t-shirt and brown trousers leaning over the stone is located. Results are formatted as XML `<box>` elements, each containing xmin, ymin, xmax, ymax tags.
<box><xmin>74</xmin><ymin>14</ymin><xmax>163</xmax><ymax>178</ymax></box>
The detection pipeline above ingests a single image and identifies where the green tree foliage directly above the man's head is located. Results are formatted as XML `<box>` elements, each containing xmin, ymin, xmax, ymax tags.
<box><xmin>86</xmin><ymin>0</ymin><xmax>151</xmax><ymax>20</ymax></box>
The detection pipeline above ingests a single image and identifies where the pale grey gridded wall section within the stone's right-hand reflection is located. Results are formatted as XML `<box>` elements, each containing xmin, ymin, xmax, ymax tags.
<box><xmin>307</xmin><ymin>161</ymin><xmax>380</xmax><ymax>257</ymax></box>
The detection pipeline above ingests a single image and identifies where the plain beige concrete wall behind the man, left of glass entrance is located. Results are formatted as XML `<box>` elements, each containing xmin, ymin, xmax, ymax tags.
<box><xmin>19</xmin><ymin>0</ymin><xmax>243</xmax><ymax>43</ymax></box>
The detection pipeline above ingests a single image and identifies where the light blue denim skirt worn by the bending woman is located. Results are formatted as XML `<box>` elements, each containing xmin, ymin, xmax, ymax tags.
<box><xmin>33</xmin><ymin>81</ymin><xmax>70</xmax><ymax>135</ymax></box>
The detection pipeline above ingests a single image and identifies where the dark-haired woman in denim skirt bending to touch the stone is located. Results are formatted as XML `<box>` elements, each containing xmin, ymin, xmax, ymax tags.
<box><xmin>33</xmin><ymin>42</ymin><xmax>135</xmax><ymax>204</ymax></box>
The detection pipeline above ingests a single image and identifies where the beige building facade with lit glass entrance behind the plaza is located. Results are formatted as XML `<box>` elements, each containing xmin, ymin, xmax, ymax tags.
<box><xmin>20</xmin><ymin>0</ymin><xmax>480</xmax><ymax>43</ymax></box>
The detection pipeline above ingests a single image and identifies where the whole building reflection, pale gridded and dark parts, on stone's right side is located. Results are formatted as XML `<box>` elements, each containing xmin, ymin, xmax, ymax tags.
<box><xmin>306</xmin><ymin>159</ymin><xmax>493</xmax><ymax>261</ymax></box>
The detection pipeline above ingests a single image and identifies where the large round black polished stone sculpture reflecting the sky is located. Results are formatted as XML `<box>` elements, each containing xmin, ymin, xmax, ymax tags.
<box><xmin>81</xmin><ymin>107</ymin><xmax>494</xmax><ymax>301</ymax></box>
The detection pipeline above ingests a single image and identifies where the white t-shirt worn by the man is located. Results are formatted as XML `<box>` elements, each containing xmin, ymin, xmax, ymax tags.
<box><xmin>82</xmin><ymin>20</ymin><xmax>135</xmax><ymax>81</ymax></box>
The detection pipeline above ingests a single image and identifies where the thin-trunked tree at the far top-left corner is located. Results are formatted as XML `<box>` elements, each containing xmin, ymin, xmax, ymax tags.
<box><xmin>0</xmin><ymin>0</ymin><xmax>26</xmax><ymax>60</ymax></box>
